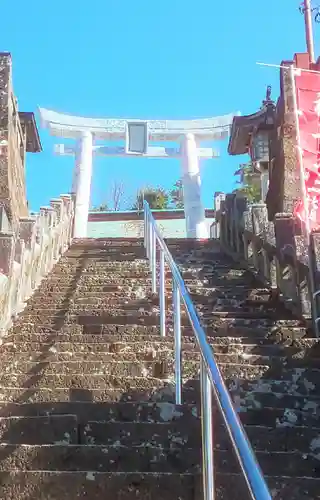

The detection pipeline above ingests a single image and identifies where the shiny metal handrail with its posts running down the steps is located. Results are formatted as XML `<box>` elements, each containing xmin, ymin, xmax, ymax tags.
<box><xmin>144</xmin><ymin>201</ymin><xmax>272</xmax><ymax>500</ymax></box>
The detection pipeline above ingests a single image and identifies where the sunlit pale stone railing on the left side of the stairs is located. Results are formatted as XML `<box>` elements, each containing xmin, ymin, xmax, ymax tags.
<box><xmin>0</xmin><ymin>195</ymin><xmax>74</xmax><ymax>335</ymax></box>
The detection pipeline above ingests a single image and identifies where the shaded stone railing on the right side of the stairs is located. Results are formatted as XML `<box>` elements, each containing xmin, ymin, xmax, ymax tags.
<box><xmin>211</xmin><ymin>194</ymin><xmax>320</xmax><ymax>326</ymax></box>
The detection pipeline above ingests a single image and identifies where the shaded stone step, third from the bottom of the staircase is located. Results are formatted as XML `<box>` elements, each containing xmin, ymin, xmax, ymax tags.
<box><xmin>0</xmin><ymin>415</ymin><xmax>314</xmax><ymax>453</ymax></box>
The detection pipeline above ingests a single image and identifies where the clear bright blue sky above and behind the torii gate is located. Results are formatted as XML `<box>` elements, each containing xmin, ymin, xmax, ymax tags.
<box><xmin>0</xmin><ymin>0</ymin><xmax>320</xmax><ymax>210</ymax></box>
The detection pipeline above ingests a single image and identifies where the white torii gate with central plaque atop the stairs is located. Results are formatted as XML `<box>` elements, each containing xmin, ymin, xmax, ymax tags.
<box><xmin>40</xmin><ymin>108</ymin><xmax>234</xmax><ymax>239</ymax></box>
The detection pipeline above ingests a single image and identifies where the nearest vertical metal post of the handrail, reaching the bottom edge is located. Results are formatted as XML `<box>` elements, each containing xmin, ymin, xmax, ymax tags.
<box><xmin>200</xmin><ymin>357</ymin><xmax>215</xmax><ymax>500</ymax></box>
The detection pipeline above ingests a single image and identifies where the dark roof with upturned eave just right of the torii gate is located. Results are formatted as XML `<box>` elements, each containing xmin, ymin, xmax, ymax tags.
<box><xmin>228</xmin><ymin>101</ymin><xmax>275</xmax><ymax>155</ymax></box>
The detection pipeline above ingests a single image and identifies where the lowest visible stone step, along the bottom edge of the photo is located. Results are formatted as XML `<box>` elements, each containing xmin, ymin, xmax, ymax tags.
<box><xmin>0</xmin><ymin>469</ymin><xmax>320</xmax><ymax>500</ymax></box>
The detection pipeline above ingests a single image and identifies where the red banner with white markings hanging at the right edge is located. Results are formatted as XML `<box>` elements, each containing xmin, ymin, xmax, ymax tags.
<box><xmin>295</xmin><ymin>71</ymin><xmax>320</xmax><ymax>229</ymax></box>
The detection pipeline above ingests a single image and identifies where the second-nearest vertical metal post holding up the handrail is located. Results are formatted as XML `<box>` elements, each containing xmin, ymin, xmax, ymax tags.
<box><xmin>172</xmin><ymin>277</ymin><xmax>181</xmax><ymax>405</ymax></box>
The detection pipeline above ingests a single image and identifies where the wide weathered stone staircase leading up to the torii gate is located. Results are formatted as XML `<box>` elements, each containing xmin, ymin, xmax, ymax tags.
<box><xmin>0</xmin><ymin>239</ymin><xmax>320</xmax><ymax>500</ymax></box>
